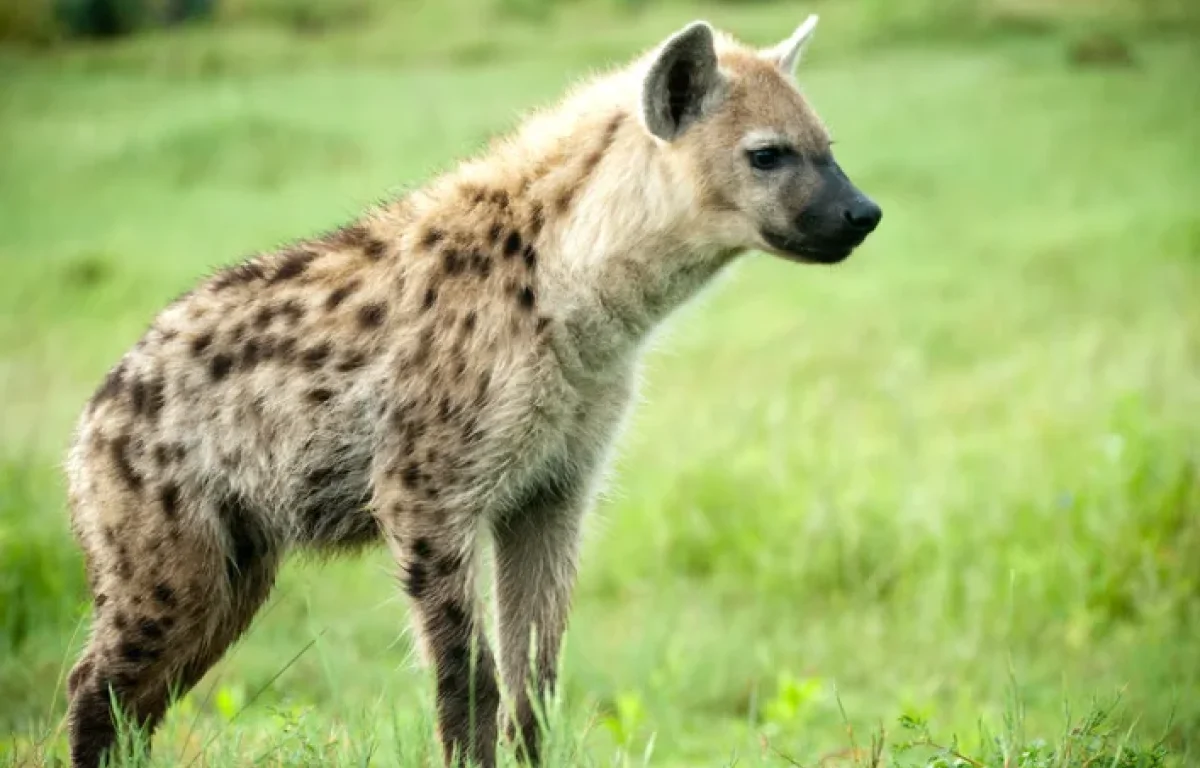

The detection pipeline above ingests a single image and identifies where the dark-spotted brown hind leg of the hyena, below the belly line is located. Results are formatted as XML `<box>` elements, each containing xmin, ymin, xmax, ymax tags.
<box><xmin>67</xmin><ymin>494</ymin><xmax>278</xmax><ymax>768</ymax></box>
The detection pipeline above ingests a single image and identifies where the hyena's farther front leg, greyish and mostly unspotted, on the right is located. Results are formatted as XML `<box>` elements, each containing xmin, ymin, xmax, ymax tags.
<box><xmin>484</xmin><ymin>485</ymin><xmax>583</xmax><ymax>764</ymax></box>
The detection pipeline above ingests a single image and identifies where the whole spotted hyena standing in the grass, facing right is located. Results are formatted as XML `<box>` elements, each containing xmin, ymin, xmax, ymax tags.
<box><xmin>67</xmin><ymin>17</ymin><xmax>881</xmax><ymax>768</ymax></box>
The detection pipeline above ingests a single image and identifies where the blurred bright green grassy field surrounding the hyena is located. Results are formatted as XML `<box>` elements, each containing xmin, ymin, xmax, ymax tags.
<box><xmin>0</xmin><ymin>0</ymin><xmax>1200</xmax><ymax>767</ymax></box>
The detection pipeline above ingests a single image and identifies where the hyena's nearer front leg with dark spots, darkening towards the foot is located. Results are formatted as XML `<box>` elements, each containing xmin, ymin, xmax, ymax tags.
<box><xmin>376</xmin><ymin>482</ymin><xmax>500</xmax><ymax>768</ymax></box>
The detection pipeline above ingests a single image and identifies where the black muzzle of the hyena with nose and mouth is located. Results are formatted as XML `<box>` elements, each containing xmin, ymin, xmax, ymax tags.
<box><xmin>763</xmin><ymin>161</ymin><xmax>883</xmax><ymax>264</ymax></box>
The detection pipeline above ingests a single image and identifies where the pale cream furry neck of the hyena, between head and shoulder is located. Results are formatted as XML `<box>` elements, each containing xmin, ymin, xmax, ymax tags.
<box><xmin>511</xmin><ymin>89</ymin><xmax>737</xmax><ymax>370</ymax></box>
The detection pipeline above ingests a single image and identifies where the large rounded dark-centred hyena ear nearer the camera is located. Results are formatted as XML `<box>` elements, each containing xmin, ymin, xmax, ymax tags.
<box><xmin>642</xmin><ymin>22</ymin><xmax>721</xmax><ymax>142</ymax></box>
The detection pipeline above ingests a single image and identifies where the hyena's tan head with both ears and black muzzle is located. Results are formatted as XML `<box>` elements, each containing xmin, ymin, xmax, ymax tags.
<box><xmin>641</xmin><ymin>16</ymin><xmax>882</xmax><ymax>264</ymax></box>
